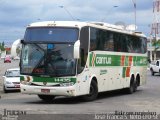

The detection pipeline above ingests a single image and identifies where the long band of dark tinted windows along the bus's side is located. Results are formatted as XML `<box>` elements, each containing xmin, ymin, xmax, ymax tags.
<box><xmin>90</xmin><ymin>28</ymin><xmax>147</xmax><ymax>53</ymax></box>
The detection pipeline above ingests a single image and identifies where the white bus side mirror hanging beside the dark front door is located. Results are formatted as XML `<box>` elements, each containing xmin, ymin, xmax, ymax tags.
<box><xmin>73</xmin><ymin>40</ymin><xmax>80</xmax><ymax>59</ymax></box>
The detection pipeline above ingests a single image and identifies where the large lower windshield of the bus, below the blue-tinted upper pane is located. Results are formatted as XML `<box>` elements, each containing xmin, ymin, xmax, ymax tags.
<box><xmin>21</xmin><ymin>43</ymin><xmax>76</xmax><ymax>76</ymax></box>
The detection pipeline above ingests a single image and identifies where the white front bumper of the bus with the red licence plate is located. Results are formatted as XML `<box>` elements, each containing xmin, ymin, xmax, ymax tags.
<box><xmin>21</xmin><ymin>84</ymin><xmax>76</xmax><ymax>96</ymax></box>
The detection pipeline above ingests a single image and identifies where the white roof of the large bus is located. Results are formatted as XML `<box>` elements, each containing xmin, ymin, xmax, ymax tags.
<box><xmin>28</xmin><ymin>21</ymin><xmax>146</xmax><ymax>37</ymax></box>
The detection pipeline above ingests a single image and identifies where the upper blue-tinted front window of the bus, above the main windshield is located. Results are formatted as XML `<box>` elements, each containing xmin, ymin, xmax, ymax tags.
<box><xmin>24</xmin><ymin>27</ymin><xmax>79</xmax><ymax>43</ymax></box>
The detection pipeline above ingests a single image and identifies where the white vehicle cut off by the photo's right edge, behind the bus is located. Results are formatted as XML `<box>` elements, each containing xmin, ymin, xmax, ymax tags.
<box><xmin>150</xmin><ymin>60</ymin><xmax>160</xmax><ymax>75</ymax></box>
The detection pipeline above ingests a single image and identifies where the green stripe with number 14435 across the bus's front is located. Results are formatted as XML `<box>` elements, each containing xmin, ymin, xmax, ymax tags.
<box><xmin>32</xmin><ymin>76</ymin><xmax>76</xmax><ymax>83</ymax></box>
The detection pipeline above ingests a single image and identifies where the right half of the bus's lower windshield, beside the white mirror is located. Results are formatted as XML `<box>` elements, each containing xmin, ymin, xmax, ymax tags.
<box><xmin>46</xmin><ymin>44</ymin><xmax>75</xmax><ymax>76</ymax></box>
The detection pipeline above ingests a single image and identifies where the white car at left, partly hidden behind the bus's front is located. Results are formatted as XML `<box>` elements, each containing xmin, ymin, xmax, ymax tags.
<box><xmin>3</xmin><ymin>68</ymin><xmax>20</xmax><ymax>93</ymax></box>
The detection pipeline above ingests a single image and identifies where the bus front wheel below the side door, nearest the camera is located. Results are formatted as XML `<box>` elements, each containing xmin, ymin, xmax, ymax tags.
<box><xmin>83</xmin><ymin>80</ymin><xmax>98</xmax><ymax>101</ymax></box>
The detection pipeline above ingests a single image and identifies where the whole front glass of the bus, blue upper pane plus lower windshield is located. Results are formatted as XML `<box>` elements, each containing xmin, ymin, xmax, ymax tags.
<box><xmin>20</xmin><ymin>27</ymin><xmax>79</xmax><ymax>76</ymax></box>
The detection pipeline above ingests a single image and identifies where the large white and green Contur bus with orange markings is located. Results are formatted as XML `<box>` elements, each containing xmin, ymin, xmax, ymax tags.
<box><xmin>20</xmin><ymin>21</ymin><xmax>147</xmax><ymax>101</ymax></box>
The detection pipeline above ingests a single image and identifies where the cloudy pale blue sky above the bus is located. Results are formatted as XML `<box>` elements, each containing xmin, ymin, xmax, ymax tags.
<box><xmin>0</xmin><ymin>0</ymin><xmax>153</xmax><ymax>45</ymax></box>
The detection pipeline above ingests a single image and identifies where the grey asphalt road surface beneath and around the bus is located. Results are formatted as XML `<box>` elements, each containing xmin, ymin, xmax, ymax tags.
<box><xmin>0</xmin><ymin>61</ymin><xmax>160</xmax><ymax>120</ymax></box>
